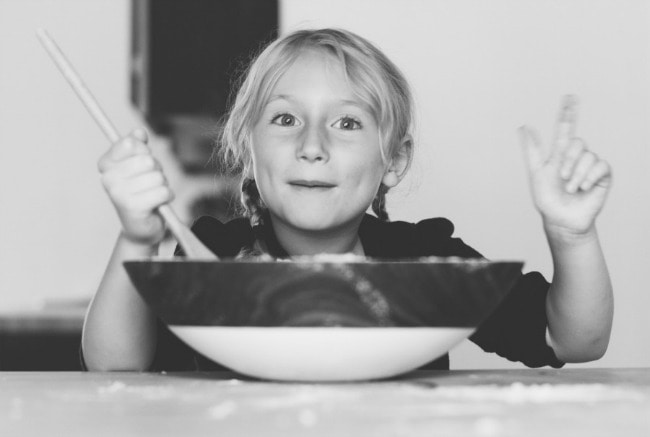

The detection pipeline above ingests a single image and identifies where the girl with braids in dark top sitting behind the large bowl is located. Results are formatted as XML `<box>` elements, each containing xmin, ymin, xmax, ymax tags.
<box><xmin>82</xmin><ymin>29</ymin><xmax>613</xmax><ymax>370</ymax></box>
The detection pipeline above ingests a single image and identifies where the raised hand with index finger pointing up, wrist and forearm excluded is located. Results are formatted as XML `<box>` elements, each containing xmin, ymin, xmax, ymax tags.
<box><xmin>519</xmin><ymin>96</ymin><xmax>612</xmax><ymax>237</ymax></box>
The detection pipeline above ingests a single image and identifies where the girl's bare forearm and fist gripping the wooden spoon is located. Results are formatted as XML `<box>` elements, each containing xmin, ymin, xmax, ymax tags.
<box><xmin>82</xmin><ymin>127</ymin><xmax>172</xmax><ymax>371</ymax></box>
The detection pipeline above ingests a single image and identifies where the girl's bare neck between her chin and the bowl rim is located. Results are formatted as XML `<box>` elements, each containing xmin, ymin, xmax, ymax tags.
<box><xmin>270</xmin><ymin>217</ymin><xmax>364</xmax><ymax>256</ymax></box>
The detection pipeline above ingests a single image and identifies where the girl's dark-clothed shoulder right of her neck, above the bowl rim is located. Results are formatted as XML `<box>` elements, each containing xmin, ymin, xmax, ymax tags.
<box><xmin>359</xmin><ymin>214</ymin><xmax>481</xmax><ymax>258</ymax></box>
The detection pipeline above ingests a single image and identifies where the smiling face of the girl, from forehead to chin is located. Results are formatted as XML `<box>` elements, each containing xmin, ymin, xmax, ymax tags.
<box><xmin>252</xmin><ymin>52</ymin><xmax>386</xmax><ymax>231</ymax></box>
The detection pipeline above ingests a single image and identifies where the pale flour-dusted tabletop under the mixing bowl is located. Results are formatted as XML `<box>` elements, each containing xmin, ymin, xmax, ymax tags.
<box><xmin>0</xmin><ymin>369</ymin><xmax>650</xmax><ymax>437</ymax></box>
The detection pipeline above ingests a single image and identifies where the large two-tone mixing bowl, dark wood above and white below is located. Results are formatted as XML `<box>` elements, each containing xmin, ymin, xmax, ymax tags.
<box><xmin>124</xmin><ymin>258</ymin><xmax>523</xmax><ymax>381</ymax></box>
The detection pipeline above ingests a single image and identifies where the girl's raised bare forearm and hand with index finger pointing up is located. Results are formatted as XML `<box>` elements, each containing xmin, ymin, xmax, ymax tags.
<box><xmin>521</xmin><ymin>97</ymin><xmax>614</xmax><ymax>362</ymax></box>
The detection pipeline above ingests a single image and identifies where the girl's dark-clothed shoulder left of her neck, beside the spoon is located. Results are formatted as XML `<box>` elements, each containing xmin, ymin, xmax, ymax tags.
<box><xmin>184</xmin><ymin>216</ymin><xmax>254</xmax><ymax>257</ymax></box>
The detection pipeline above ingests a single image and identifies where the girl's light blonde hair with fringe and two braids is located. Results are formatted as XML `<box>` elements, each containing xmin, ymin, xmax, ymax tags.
<box><xmin>220</xmin><ymin>29</ymin><xmax>413</xmax><ymax>226</ymax></box>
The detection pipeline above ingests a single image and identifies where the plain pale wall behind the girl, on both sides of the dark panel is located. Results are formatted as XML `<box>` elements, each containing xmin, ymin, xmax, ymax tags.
<box><xmin>0</xmin><ymin>0</ymin><xmax>650</xmax><ymax>368</ymax></box>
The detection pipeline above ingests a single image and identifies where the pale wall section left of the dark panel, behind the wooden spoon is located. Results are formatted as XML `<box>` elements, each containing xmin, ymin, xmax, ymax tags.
<box><xmin>0</xmin><ymin>0</ymin><xmax>191</xmax><ymax>310</ymax></box>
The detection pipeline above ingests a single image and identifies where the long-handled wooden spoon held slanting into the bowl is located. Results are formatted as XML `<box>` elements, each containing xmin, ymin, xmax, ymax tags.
<box><xmin>36</xmin><ymin>29</ymin><xmax>218</xmax><ymax>259</ymax></box>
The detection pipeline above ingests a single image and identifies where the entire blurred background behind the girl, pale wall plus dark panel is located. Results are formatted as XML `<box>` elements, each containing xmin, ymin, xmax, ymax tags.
<box><xmin>0</xmin><ymin>0</ymin><xmax>650</xmax><ymax>370</ymax></box>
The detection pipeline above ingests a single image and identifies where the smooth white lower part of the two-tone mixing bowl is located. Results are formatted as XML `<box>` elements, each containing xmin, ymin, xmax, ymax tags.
<box><xmin>169</xmin><ymin>326</ymin><xmax>474</xmax><ymax>382</ymax></box>
